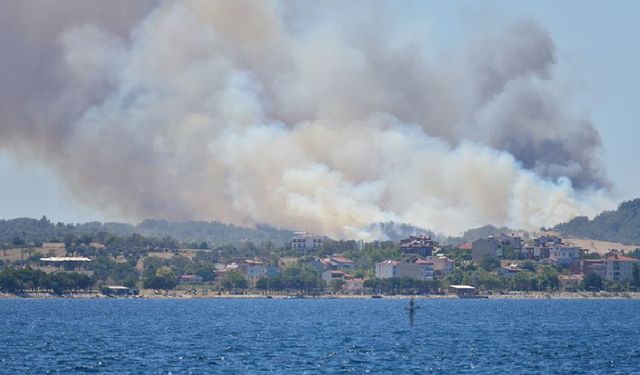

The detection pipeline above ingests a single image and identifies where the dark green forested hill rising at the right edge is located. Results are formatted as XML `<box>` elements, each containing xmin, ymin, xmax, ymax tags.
<box><xmin>555</xmin><ymin>199</ymin><xmax>640</xmax><ymax>245</ymax></box>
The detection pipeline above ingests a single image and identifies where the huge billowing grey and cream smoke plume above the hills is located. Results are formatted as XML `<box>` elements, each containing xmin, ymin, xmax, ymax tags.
<box><xmin>0</xmin><ymin>0</ymin><xmax>610</xmax><ymax>237</ymax></box>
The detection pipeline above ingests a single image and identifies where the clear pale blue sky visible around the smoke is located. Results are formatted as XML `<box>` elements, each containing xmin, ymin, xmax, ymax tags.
<box><xmin>0</xmin><ymin>1</ymin><xmax>640</xmax><ymax>234</ymax></box>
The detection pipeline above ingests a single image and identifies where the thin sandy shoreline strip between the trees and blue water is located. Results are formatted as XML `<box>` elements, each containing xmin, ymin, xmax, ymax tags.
<box><xmin>0</xmin><ymin>290</ymin><xmax>640</xmax><ymax>300</ymax></box>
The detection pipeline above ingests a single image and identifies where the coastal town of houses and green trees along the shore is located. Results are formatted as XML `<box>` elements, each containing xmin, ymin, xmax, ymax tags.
<box><xmin>0</xmin><ymin>220</ymin><xmax>640</xmax><ymax>298</ymax></box>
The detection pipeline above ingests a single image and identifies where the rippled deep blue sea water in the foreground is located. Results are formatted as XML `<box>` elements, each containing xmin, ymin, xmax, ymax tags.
<box><xmin>0</xmin><ymin>299</ymin><xmax>640</xmax><ymax>374</ymax></box>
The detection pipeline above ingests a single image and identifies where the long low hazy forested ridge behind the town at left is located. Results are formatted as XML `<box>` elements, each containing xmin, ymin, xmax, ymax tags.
<box><xmin>0</xmin><ymin>217</ymin><xmax>293</xmax><ymax>245</ymax></box>
